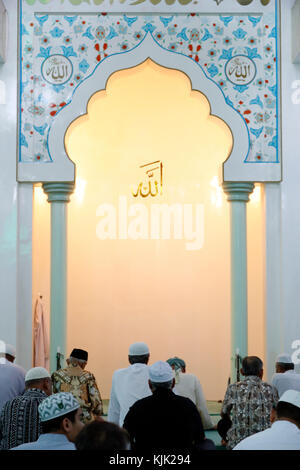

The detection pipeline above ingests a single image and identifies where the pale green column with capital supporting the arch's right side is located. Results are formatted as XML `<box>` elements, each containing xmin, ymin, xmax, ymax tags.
<box><xmin>223</xmin><ymin>182</ymin><xmax>254</xmax><ymax>382</ymax></box>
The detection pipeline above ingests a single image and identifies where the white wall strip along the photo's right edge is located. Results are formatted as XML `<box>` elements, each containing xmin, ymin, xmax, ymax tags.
<box><xmin>279</xmin><ymin>0</ymin><xmax>300</xmax><ymax>367</ymax></box>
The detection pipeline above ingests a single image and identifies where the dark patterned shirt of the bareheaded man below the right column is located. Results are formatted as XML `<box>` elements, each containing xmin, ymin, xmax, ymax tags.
<box><xmin>221</xmin><ymin>375</ymin><xmax>278</xmax><ymax>449</ymax></box>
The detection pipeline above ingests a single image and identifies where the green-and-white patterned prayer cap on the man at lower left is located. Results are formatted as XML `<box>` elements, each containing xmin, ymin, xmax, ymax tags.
<box><xmin>38</xmin><ymin>392</ymin><xmax>80</xmax><ymax>422</ymax></box>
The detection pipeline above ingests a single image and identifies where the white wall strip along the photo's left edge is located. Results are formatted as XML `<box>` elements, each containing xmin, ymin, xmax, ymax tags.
<box><xmin>0</xmin><ymin>0</ymin><xmax>32</xmax><ymax>368</ymax></box>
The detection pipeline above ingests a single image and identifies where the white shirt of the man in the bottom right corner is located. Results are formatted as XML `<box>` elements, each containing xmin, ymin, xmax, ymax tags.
<box><xmin>233</xmin><ymin>420</ymin><xmax>300</xmax><ymax>450</ymax></box>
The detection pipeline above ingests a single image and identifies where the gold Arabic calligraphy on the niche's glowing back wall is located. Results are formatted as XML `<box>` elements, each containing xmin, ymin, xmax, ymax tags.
<box><xmin>131</xmin><ymin>160</ymin><xmax>163</xmax><ymax>197</ymax></box>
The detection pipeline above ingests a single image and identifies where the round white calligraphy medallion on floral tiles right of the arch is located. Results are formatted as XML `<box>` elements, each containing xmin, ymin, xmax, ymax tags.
<box><xmin>225</xmin><ymin>55</ymin><xmax>256</xmax><ymax>85</ymax></box>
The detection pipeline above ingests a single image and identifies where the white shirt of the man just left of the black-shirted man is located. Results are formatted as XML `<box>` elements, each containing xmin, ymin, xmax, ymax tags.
<box><xmin>107</xmin><ymin>363</ymin><xmax>151</xmax><ymax>426</ymax></box>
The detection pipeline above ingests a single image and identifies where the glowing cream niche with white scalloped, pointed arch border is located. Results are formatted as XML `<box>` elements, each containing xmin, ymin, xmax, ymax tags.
<box><xmin>35</xmin><ymin>34</ymin><xmax>263</xmax><ymax>399</ymax></box>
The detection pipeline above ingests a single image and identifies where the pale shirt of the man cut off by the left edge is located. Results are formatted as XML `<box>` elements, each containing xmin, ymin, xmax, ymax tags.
<box><xmin>0</xmin><ymin>358</ymin><xmax>25</xmax><ymax>411</ymax></box>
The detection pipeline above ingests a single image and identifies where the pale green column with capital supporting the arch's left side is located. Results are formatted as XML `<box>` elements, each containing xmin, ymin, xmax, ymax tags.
<box><xmin>43</xmin><ymin>183</ymin><xmax>74</xmax><ymax>372</ymax></box>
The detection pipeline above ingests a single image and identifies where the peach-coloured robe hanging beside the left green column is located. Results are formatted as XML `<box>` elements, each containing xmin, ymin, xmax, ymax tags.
<box><xmin>33</xmin><ymin>299</ymin><xmax>49</xmax><ymax>370</ymax></box>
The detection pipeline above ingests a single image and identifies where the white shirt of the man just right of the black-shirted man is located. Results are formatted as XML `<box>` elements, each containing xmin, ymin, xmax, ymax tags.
<box><xmin>173</xmin><ymin>372</ymin><xmax>213</xmax><ymax>429</ymax></box>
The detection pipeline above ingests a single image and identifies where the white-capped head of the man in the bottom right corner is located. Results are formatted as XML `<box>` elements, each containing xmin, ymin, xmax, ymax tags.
<box><xmin>271</xmin><ymin>390</ymin><xmax>300</xmax><ymax>428</ymax></box>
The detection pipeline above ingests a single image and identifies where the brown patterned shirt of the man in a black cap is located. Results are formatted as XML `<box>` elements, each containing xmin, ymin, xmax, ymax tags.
<box><xmin>52</xmin><ymin>365</ymin><xmax>103</xmax><ymax>423</ymax></box>
